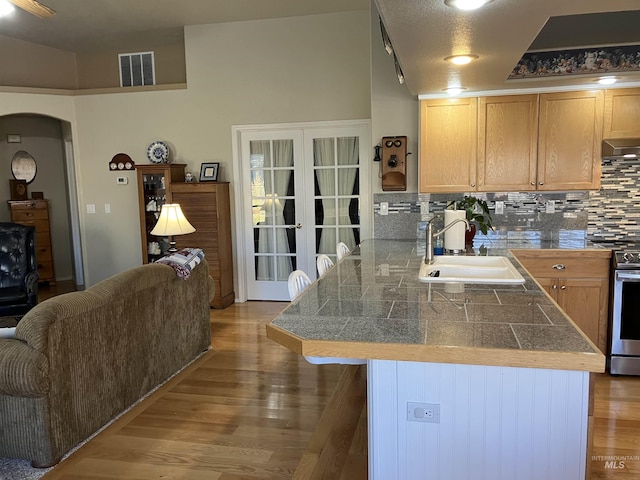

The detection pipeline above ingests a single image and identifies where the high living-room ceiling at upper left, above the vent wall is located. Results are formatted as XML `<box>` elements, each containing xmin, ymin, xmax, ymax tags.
<box><xmin>0</xmin><ymin>0</ymin><xmax>369</xmax><ymax>52</ymax></box>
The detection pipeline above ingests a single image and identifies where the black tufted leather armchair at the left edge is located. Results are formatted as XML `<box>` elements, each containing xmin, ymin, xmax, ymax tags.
<box><xmin>0</xmin><ymin>222</ymin><xmax>39</xmax><ymax>317</ymax></box>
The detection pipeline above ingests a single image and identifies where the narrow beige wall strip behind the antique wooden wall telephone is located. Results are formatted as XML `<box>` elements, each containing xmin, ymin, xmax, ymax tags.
<box><xmin>371</xmin><ymin>0</ymin><xmax>419</xmax><ymax>193</ymax></box>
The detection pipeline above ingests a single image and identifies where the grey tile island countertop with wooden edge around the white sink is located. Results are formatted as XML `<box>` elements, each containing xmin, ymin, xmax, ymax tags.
<box><xmin>267</xmin><ymin>239</ymin><xmax>605</xmax><ymax>372</ymax></box>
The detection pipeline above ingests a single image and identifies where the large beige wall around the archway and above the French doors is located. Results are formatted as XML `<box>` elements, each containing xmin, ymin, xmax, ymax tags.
<box><xmin>0</xmin><ymin>11</ymin><xmax>370</xmax><ymax>285</ymax></box>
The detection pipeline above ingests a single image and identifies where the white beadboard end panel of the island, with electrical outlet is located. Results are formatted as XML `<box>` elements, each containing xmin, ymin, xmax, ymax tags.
<box><xmin>368</xmin><ymin>360</ymin><xmax>589</xmax><ymax>480</ymax></box>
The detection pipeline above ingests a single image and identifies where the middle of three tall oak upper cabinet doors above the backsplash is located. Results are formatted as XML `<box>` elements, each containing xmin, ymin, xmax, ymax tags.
<box><xmin>477</xmin><ymin>95</ymin><xmax>538</xmax><ymax>192</ymax></box>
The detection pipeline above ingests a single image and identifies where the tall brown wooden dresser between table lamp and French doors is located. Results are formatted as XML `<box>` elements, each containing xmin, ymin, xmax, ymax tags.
<box><xmin>171</xmin><ymin>182</ymin><xmax>235</xmax><ymax>308</ymax></box>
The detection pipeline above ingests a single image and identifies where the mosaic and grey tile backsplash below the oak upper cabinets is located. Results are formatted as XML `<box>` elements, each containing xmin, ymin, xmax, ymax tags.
<box><xmin>374</xmin><ymin>159</ymin><xmax>640</xmax><ymax>246</ymax></box>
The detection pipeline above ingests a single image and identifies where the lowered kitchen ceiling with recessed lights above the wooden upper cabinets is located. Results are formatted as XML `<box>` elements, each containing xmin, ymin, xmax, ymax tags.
<box><xmin>374</xmin><ymin>0</ymin><xmax>640</xmax><ymax>96</ymax></box>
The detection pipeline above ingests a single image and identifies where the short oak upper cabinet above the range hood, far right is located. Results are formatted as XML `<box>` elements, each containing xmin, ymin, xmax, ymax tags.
<box><xmin>602</xmin><ymin>88</ymin><xmax>640</xmax><ymax>139</ymax></box>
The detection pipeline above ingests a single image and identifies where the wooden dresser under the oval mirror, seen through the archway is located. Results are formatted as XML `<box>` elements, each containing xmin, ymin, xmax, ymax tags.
<box><xmin>9</xmin><ymin>199</ymin><xmax>56</xmax><ymax>285</ymax></box>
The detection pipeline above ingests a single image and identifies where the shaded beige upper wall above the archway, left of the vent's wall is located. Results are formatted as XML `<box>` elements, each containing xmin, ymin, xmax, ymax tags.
<box><xmin>0</xmin><ymin>35</ymin><xmax>78</xmax><ymax>89</ymax></box>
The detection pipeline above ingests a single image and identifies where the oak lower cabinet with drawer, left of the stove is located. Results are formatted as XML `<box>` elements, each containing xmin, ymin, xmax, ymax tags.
<box><xmin>512</xmin><ymin>250</ymin><xmax>611</xmax><ymax>353</ymax></box>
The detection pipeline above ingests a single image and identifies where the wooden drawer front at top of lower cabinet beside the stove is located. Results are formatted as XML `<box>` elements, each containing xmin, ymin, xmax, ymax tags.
<box><xmin>513</xmin><ymin>250</ymin><xmax>610</xmax><ymax>278</ymax></box>
